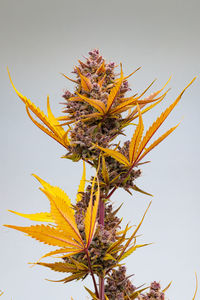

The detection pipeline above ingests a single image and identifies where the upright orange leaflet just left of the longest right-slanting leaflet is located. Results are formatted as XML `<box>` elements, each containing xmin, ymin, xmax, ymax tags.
<box><xmin>129</xmin><ymin>104</ymin><xmax>144</xmax><ymax>164</ymax></box>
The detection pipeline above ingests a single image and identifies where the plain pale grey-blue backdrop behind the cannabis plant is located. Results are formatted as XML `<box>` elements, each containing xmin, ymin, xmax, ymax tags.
<box><xmin>0</xmin><ymin>0</ymin><xmax>200</xmax><ymax>300</ymax></box>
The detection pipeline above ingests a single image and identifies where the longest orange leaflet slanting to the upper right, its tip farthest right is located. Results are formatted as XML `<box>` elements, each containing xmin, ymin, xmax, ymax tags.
<box><xmin>137</xmin><ymin>78</ymin><xmax>196</xmax><ymax>159</ymax></box>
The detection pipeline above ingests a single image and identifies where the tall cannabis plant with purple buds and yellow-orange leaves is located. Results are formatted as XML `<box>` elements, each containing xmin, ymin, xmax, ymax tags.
<box><xmin>5</xmin><ymin>49</ymin><xmax>195</xmax><ymax>300</ymax></box>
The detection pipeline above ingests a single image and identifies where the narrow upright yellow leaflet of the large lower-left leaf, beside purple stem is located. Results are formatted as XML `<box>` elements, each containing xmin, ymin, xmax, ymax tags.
<box><xmin>84</xmin><ymin>177</ymin><xmax>100</xmax><ymax>248</ymax></box>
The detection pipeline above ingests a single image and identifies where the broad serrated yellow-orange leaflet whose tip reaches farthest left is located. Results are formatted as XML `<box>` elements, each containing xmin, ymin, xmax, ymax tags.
<box><xmin>4</xmin><ymin>225</ymin><xmax>82</xmax><ymax>248</ymax></box>
